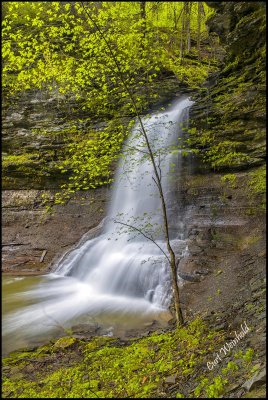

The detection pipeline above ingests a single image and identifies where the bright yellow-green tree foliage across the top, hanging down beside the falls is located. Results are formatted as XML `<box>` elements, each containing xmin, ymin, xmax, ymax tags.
<box><xmin>2</xmin><ymin>2</ymin><xmax>218</xmax><ymax>201</ymax></box>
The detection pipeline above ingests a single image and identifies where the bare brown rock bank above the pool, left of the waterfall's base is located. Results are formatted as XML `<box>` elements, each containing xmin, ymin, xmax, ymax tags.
<box><xmin>2</xmin><ymin>188</ymin><xmax>110</xmax><ymax>275</ymax></box>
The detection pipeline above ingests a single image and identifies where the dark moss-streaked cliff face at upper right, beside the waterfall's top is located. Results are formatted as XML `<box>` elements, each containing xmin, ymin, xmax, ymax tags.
<box><xmin>191</xmin><ymin>2</ymin><xmax>266</xmax><ymax>170</ymax></box>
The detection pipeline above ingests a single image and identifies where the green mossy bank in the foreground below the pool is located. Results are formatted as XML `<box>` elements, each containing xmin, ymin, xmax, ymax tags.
<box><xmin>0</xmin><ymin>319</ymin><xmax>260</xmax><ymax>398</ymax></box>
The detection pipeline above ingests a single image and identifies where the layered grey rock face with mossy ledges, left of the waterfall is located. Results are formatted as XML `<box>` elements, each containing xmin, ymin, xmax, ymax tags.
<box><xmin>2</xmin><ymin>91</ymin><xmax>90</xmax><ymax>189</ymax></box>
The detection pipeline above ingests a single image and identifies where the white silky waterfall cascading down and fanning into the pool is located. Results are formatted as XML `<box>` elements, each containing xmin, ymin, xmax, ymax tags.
<box><xmin>3</xmin><ymin>98</ymin><xmax>192</xmax><ymax>354</ymax></box>
